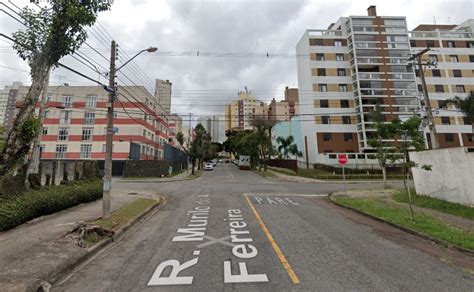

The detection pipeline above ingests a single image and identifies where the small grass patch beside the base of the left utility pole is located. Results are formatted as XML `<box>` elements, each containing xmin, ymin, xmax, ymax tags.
<box><xmin>90</xmin><ymin>198</ymin><xmax>156</xmax><ymax>231</ymax></box>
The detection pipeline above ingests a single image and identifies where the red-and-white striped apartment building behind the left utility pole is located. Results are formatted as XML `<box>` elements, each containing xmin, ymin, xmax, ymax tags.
<box><xmin>7</xmin><ymin>86</ymin><xmax>168</xmax><ymax>160</ymax></box>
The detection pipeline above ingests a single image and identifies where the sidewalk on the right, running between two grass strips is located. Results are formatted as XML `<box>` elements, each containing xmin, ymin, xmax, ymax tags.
<box><xmin>333</xmin><ymin>189</ymin><xmax>474</xmax><ymax>233</ymax></box>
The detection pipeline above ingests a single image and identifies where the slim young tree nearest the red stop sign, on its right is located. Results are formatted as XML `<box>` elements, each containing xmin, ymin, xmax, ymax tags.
<box><xmin>368</xmin><ymin>105</ymin><xmax>396</xmax><ymax>188</ymax></box>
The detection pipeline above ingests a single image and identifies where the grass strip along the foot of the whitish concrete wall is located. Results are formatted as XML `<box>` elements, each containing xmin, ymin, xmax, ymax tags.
<box><xmin>393</xmin><ymin>190</ymin><xmax>474</xmax><ymax>220</ymax></box>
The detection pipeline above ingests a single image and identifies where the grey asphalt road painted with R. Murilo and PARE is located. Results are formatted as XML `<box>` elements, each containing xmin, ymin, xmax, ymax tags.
<box><xmin>54</xmin><ymin>164</ymin><xmax>474</xmax><ymax>291</ymax></box>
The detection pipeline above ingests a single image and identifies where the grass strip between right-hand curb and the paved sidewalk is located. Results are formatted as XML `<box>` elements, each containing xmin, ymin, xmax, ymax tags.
<box><xmin>333</xmin><ymin>196</ymin><xmax>474</xmax><ymax>251</ymax></box>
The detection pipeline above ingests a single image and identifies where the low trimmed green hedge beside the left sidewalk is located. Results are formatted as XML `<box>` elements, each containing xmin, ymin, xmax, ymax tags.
<box><xmin>0</xmin><ymin>180</ymin><xmax>102</xmax><ymax>231</ymax></box>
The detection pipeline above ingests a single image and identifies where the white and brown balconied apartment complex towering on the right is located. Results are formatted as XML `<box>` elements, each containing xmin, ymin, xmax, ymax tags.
<box><xmin>296</xmin><ymin>6</ymin><xmax>474</xmax><ymax>164</ymax></box>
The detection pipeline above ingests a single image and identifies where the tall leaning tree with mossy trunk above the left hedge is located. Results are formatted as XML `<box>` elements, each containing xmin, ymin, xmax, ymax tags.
<box><xmin>0</xmin><ymin>0</ymin><xmax>112</xmax><ymax>175</ymax></box>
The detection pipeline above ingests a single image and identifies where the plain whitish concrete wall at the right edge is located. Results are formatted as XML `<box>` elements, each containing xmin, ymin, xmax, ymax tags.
<box><xmin>410</xmin><ymin>147</ymin><xmax>474</xmax><ymax>206</ymax></box>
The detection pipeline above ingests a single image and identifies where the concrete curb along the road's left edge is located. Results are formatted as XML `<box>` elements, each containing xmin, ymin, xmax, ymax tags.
<box><xmin>43</xmin><ymin>196</ymin><xmax>166</xmax><ymax>291</ymax></box>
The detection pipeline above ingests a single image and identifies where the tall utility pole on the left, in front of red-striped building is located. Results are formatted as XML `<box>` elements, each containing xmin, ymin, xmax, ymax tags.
<box><xmin>102</xmin><ymin>41</ymin><xmax>117</xmax><ymax>218</ymax></box>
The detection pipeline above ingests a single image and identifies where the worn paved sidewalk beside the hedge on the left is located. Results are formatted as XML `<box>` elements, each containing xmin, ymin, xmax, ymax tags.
<box><xmin>0</xmin><ymin>182</ymin><xmax>158</xmax><ymax>291</ymax></box>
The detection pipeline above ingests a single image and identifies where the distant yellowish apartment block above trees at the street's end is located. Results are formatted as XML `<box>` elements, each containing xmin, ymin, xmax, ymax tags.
<box><xmin>225</xmin><ymin>91</ymin><xmax>268</xmax><ymax>131</ymax></box>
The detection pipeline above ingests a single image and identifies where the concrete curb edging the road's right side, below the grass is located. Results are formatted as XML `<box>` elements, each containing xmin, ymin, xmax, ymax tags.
<box><xmin>328</xmin><ymin>196</ymin><xmax>474</xmax><ymax>257</ymax></box>
